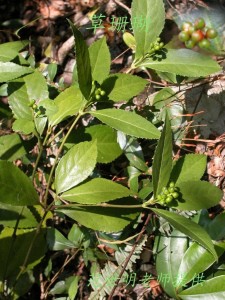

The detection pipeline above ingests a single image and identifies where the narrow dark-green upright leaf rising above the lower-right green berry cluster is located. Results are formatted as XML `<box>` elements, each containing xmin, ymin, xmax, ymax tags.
<box><xmin>152</xmin><ymin>115</ymin><xmax>172</xmax><ymax>197</ymax></box>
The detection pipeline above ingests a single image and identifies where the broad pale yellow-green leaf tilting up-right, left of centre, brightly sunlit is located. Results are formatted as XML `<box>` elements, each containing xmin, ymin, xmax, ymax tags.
<box><xmin>55</xmin><ymin>141</ymin><xmax>97</xmax><ymax>194</ymax></box>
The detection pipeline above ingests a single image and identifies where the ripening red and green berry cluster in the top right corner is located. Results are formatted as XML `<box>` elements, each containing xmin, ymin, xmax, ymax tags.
<box><xmin>178</xmin><ymin>18</ymin><xmax>218</xmax><ymax>49</ymax></box>
